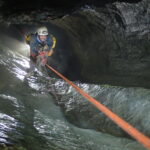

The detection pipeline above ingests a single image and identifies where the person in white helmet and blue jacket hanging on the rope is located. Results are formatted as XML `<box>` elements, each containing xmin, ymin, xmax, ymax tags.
<box><xmin>25</xmin><ymin>26</ymin><xmax>56</xmax><ymax>77</ymax></box>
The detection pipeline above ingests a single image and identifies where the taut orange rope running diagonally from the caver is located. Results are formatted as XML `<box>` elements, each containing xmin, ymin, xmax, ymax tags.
<box><xmin>46</xmin><ymin>64</ymin><xmax>150</xmax><ymax>150</ymax></box>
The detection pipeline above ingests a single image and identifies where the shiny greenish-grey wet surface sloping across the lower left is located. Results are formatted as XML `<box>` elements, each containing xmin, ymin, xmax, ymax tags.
<box><xmin>0</xmin><ymin>41</ymin><xmax>144</xmax><ymax>150</ymax></box>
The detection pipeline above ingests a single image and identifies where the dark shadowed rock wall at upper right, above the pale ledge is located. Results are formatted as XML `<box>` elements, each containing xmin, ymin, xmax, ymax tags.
<box><xmin>54</xmin><ymin>0</ymin><xmax>150</xmax><ymax>88</ymax></box>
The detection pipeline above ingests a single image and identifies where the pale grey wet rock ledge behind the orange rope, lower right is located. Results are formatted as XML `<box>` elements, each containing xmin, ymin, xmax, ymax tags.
<box><xmin>56</xmin><ymin>83</ymin><xmax>150</xmax><ymax>137</ymax></box>
